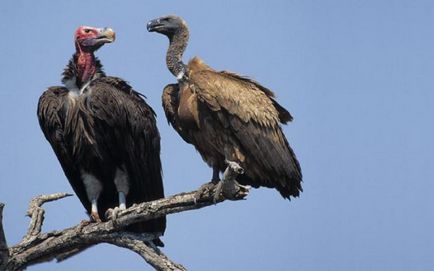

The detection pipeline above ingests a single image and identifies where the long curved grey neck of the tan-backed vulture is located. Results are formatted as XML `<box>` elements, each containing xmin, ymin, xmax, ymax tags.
<box><xmin>166</xmin><ymin>28</ymin><xmax>188</xmax><ymax>80</ymax></box>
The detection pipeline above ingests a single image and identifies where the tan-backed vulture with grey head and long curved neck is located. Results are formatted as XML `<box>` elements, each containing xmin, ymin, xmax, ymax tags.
<box><xmin>147</xmin><ymin>15</ymin><xmax>302</xmax><ymax>199</ymax></box>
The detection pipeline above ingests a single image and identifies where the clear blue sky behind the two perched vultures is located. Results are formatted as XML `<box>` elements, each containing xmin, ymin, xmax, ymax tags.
<box><xmin>0</xmin><ymin>0</ymin><xmax>434</xmax><ymax>270</ymax></box>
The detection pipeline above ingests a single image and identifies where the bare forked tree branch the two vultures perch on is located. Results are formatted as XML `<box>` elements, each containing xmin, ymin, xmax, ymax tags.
<box><xmin>0</xmin><ymin>170</ymin><xmax>247</xmax><ymax>270</ymax></box>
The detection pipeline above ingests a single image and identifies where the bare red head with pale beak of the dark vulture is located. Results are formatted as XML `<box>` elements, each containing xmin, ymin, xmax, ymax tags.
<box><xmin>74</xmin><ymin>26</ymin><xmax>116</xmax><ymax>52</ymax></box>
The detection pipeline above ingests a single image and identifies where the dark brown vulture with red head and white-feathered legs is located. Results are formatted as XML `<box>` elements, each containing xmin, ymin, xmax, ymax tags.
<box><xmin>37</xmin><ymin>26</ymin><xmax>166</xmax><ymax>245</ymax></box>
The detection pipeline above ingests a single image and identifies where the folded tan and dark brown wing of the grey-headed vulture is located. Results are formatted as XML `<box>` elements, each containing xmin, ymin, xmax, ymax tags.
<box><xmin>189</xmin><ymin>66</ymin><xmax>302</xmax><ymax>198</ymax></box>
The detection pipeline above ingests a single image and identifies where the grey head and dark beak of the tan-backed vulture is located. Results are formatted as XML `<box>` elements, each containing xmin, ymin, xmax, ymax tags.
<box><xmin>147</xmin><ymin>15</ymin><xmax>188</xmax><ymax>38</ymax></box>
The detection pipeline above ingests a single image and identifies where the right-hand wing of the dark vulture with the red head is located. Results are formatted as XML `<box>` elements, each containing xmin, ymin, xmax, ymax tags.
<box><xmin>87</xmin><ymin>77</ymin><xmax>166</xmax><ymax>231</ymax></box>
